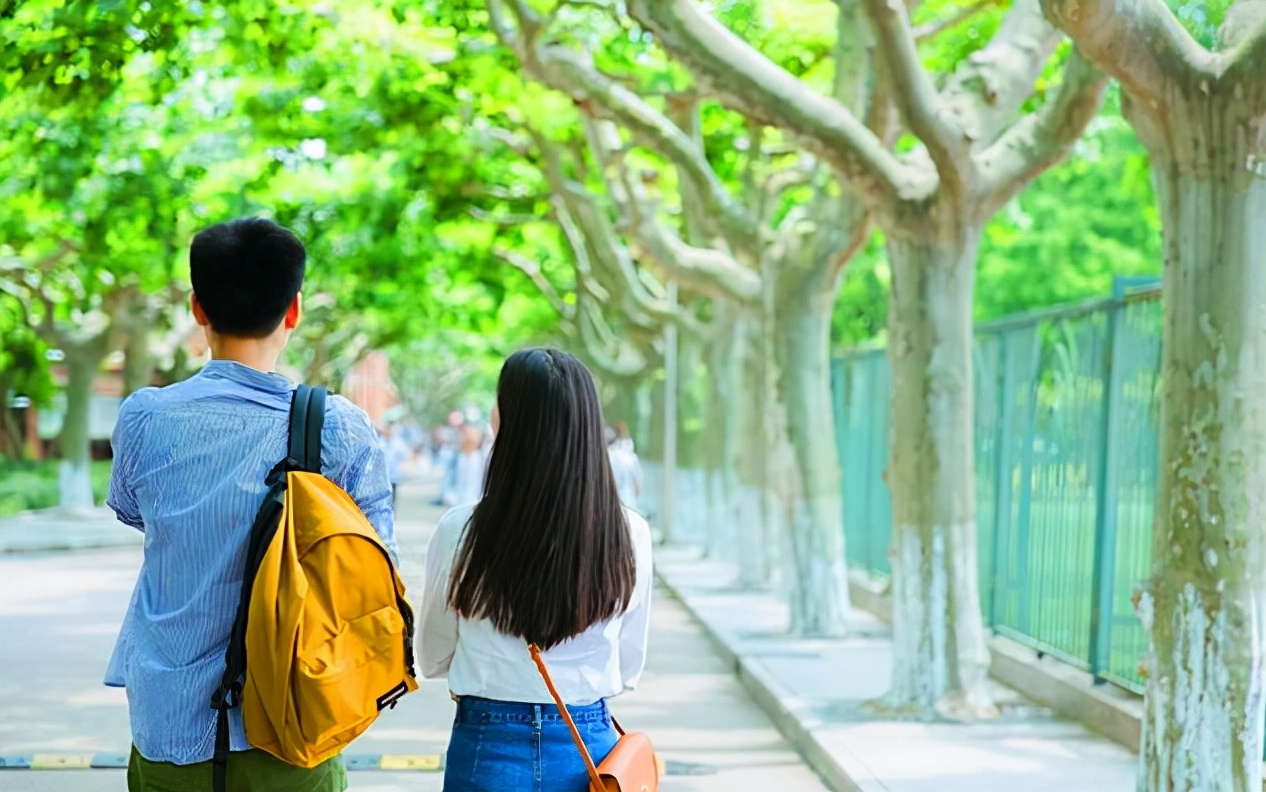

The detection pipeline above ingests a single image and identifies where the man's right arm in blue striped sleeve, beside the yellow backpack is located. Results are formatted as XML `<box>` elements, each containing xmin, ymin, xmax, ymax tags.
<box><xmin>322</xmin><ymin>395</ymin><xmax>400</xmax><ymax>563</ymax></box>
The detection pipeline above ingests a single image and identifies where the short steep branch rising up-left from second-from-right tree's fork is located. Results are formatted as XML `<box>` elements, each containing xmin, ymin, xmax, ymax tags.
<box><xmin>863</xmin><ymin>0</ymin><xmax>970</xmax><ymax>195</ymax></box>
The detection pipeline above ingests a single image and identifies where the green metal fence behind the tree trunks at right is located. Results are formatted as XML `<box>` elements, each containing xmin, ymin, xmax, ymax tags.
<box><xmin>833</xmin><ymin>292</ymin><xmax>1161</xmax><ymax>691</ymax></box>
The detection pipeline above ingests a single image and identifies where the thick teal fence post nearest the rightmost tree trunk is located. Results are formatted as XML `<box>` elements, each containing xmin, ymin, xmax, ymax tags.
<box><xmin>1087</xmin><ymin>295</ymin><xmax>1124</xmax><ymax>684</ymax></box>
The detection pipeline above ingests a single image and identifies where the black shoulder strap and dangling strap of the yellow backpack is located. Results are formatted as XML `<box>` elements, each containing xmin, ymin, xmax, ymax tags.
<box><xmin>211</xmin><ymin>385</ymin><xmax>325</xmax><ymax>792</ymax></box>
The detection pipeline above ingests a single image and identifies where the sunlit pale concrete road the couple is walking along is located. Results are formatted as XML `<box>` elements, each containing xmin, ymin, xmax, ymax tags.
<box><xmin>0</xmin><ymin>475</ymin><xmax>825</xmax><ymax>792</ymax></box>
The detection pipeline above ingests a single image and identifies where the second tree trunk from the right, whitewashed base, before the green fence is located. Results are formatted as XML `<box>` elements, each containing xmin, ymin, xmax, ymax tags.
<box><xmin>884</xmin><ymin>221</ymin><xmax>996</xmax><ymax>720</ymax></box>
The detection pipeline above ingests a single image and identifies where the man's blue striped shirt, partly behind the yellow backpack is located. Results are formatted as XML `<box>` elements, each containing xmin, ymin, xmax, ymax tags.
<box><xmin>105</xmin><ymin>361</ymin><xmax>396</xmax><ymax>764</ymax></box>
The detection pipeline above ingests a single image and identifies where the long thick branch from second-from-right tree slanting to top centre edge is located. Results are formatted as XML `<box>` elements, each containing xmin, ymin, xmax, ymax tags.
<box><xmin>629</xmin><ymin>0</ymin><xmax>934</xmax><ymax>205</ymax></box>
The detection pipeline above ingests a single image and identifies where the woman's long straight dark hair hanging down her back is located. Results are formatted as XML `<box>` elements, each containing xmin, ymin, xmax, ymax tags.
<box><xmin>448</xmin><ymin>348</ymin><xmax>636</xmax><ymax>649</ymax></box>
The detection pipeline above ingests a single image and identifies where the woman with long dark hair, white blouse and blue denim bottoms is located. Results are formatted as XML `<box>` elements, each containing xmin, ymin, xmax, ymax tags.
<box><xmin>420</xmin><ymin>349</ymin><xmax>651</xmax><ymax>792</ymax></box>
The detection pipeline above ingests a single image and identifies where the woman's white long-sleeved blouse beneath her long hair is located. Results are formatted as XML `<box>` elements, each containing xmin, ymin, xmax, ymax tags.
<box><xmin>418</xmin><ymin>505</ymin><xmax>652</xmax><ymax>705</ymax></box>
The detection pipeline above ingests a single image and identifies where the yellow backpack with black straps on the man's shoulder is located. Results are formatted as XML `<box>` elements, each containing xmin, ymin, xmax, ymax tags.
<box><xmin>211</xmin><ymin>385</ymin><xmax>418</xmax><ymax>792</ymax></box>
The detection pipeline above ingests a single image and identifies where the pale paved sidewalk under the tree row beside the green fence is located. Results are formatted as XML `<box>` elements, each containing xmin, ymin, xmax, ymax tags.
<box><xmin>656</xmin><ymin>548</ymin><xmax>1136</xmax><ymax>792</ymax></box>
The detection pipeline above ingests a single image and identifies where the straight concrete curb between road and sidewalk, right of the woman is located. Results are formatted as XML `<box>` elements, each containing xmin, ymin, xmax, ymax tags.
<box><xmin>656</xmin><ymin>569</ymin><xmax>871</xmax><ymax>792</ymax></box>
